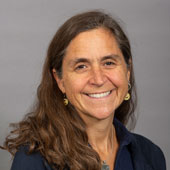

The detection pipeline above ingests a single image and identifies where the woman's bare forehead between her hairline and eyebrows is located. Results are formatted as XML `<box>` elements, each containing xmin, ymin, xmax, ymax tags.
<box><xmin>65</xmin><ymin>28</ymin><xmax>122</xmax><ymax>62</ymax></box>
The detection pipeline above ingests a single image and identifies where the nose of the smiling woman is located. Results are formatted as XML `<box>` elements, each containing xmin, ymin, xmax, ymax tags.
<box><xmin>90</xmin><ymin>67</ymin><xmax>106</xmax><ymax>86</ymax></box>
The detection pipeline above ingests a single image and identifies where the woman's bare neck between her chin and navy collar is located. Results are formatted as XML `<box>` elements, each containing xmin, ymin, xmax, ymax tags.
<box><xmin>83</xmin><ymin>114</ymin><xmax>119</xmax><ymax>169</ymax></box>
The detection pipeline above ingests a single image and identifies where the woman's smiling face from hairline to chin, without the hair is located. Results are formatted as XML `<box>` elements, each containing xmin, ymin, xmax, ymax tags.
<box><xmin>53</xmin><ymin>28</ymin><xmax>130</xmax><ymax>120</ymax></box>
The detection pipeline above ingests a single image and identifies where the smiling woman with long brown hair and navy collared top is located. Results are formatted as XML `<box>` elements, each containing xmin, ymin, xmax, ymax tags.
<box><xmin>2</xmin><ymin>11</ymin><xmax>166</xmax><ymax>170</ymax></box>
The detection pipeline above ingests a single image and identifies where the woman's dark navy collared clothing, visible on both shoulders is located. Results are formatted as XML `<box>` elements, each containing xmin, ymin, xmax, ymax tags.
<box><xmin>11</xmin><ymin>120</ymin><xmax>166</xmax><ymax>170</ymax></box>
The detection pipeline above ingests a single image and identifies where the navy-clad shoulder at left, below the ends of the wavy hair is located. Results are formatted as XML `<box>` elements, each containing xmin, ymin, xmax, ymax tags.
<box><xmin>11</xmin><ymin>147</ymin><xmax>52</xmax><ymax>170</ymax></box>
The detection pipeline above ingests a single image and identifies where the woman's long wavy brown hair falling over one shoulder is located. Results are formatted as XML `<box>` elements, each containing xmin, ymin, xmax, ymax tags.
<box><xmin>4</xmin><ymin>11</ymin><xmax>136</xmax><ymax>170</ymax></box>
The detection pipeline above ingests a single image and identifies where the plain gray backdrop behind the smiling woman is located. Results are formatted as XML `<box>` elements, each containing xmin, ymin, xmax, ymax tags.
<box><xmin>0</xmin><ymin>0</ymin><xmax>170</xmax><ymax>170</ymax></box>
